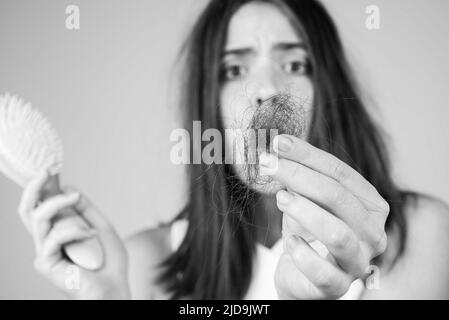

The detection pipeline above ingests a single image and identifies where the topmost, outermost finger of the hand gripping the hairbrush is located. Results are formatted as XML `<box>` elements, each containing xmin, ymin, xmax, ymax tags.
<box><xmin>18</xmin><ymin>171</ymin><xmax>49</xmax><ymax>231</ymax></box>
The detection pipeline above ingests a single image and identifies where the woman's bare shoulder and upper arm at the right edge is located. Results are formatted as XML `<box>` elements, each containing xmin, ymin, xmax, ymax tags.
<box><xmin>363</xmin><ymin>196</ymin><xmax>449</xmax><ymax>299</ymax></box>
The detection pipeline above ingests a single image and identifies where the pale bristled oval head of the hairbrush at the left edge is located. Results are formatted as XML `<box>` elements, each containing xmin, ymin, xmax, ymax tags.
<box><xmin>0</xmin><ymin>93</ymin><xmax>63</xmax><ymax>186</ymax></box>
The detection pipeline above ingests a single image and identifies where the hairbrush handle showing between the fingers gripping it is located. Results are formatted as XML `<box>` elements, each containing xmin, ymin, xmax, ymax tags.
<box><xmin>41</xmin><ymin>175</ymin><xmax>104</xmax><ymax>270</ymax></box>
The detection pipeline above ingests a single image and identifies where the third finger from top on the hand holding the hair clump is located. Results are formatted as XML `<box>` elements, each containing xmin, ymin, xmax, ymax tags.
<box><xmin>277</xmin><ymin>190</ymin><xmax>370</xmax><ymax>278</ymax></box>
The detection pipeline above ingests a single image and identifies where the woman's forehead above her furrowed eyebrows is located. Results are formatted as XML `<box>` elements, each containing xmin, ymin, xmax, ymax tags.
<box><xmin>225</xmin><ymin>2</ymin><xmax>302</xmax><ymax>50</ymax></box>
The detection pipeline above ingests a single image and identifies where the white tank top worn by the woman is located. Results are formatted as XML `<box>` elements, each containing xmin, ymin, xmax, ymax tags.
<box><xmin>170</xmin><ymin>219</ymin><xmax>365</xmax><ymax>300</ymax></box>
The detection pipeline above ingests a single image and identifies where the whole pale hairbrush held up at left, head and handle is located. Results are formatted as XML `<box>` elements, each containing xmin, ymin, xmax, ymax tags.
<box><xmin>0</xmin><ymin>93</ymin><xmax>103</xmax><ymax>270</ymax></box>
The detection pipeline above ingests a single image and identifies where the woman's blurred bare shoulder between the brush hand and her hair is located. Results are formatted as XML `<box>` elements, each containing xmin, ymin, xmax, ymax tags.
<box><xmin>125</xmin><ymin>223</ymin><xmax>177</xmax><ymax>299</ymax></box>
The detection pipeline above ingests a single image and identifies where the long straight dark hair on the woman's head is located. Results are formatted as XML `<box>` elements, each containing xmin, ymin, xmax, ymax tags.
<box><xmin>160</xmin><ymin>0</ymin><xmax>408</xmax><ymax>299</ymax></box>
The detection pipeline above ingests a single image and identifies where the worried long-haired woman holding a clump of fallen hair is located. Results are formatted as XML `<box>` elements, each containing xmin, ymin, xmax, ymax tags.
<box><xmin>19</xmin><ymin>0</ymin><xmax>449</xmax><ymax>299</ymax></box>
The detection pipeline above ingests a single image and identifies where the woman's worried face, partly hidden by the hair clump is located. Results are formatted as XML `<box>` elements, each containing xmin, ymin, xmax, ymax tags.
<box><xmin>220</xmin><ymin>2</ymin><xmax>313</xmax><ymax>193</ymax></box>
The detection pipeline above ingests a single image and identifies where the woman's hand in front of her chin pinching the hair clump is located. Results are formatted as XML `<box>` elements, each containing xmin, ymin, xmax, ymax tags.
<box><xmin>260</xmin><ymin>135</ymin><xmax>389</xmax><ymax>299</ymax></box>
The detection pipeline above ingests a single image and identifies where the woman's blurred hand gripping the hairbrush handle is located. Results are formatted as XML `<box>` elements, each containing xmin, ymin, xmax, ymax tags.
<box><xmin>19</xmin><ymin>173</ymin><xmax>129</xmax><ymax>299</ymax></box>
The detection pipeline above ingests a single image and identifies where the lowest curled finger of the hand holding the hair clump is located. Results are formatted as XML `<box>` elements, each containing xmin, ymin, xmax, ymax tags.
<box><xmin>286</xmin><ymin>235</ymin><xmax>354</xmax><ymax>299</ymax></box>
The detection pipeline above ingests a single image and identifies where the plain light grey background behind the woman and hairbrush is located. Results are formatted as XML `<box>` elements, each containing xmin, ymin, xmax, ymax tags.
<box><xmin>0</xmin><ymin>0</ymin><xmax>449</xmax><ymax>299</ymax></box>
